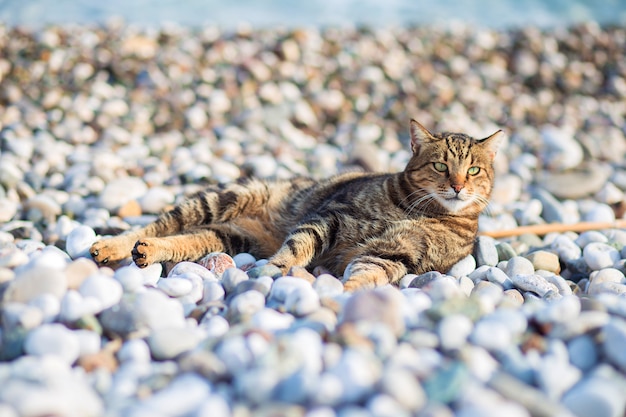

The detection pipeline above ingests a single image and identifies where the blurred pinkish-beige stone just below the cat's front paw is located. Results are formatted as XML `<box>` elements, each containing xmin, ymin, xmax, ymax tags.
<box><xmin>340</xmin><ymin>290</ymin><xmax>405</xmax><ymax>336</ymax></box>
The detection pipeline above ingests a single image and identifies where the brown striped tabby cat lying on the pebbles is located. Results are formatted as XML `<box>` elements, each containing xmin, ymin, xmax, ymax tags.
<box><xmin>90</xmin><ymin>120</ymin><xmax>503</xmax><ymax>291</ymax></box>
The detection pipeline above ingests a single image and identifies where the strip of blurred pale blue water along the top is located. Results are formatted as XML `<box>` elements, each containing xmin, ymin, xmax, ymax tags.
<box><xmin>0</xmin><ymin>0</ymin><xmax>626</xmax><ymax>29</ymax></box>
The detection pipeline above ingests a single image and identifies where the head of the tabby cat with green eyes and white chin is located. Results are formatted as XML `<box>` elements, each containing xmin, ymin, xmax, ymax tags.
<box><xmin>405</xmin><ymin>120</ymin><xmax>504</xmax><ymax>215</ymax></box>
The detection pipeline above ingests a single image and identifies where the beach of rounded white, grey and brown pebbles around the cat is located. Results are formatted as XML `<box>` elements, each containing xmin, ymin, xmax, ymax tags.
<box><xmin>0</xmin><ymin>20</ymin><xmax>626</xmax><ymax>417</ymax></box>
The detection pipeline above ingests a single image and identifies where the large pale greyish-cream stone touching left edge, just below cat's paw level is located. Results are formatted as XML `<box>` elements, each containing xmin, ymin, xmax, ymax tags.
<box><xmin>3</xmin><ymin>267</ymin><xmax>67</xmax><ymax>303</ymax></box>
